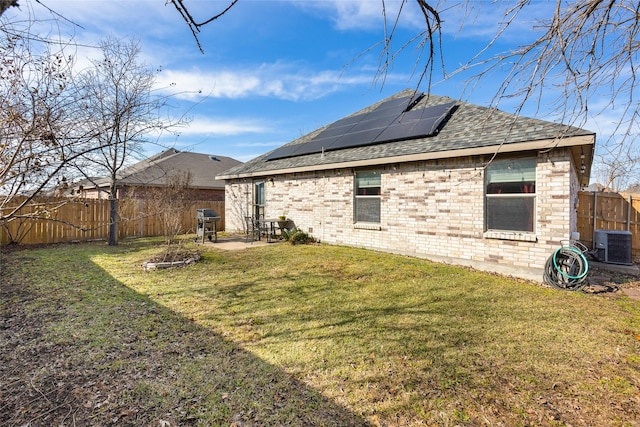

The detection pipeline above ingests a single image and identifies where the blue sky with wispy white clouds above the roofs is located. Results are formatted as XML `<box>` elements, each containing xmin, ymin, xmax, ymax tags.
<box><xmin>7</xmin><ymin>0</ymin><xmax>624</xmax><ymax>169</ymax></box>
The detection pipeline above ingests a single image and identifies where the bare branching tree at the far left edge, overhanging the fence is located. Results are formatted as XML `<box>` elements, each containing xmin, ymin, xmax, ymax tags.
<box><xmin>0</xmin><ymin>17</ymin><xmax>101</xmax><ymax>229</ymax></box>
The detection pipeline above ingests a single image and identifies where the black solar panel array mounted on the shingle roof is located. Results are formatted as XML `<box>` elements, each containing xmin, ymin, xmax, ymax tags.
<box><xmin>265</xmin><ymin>94</ymin><xmax>455</xmax><ymax>160</ymax></box>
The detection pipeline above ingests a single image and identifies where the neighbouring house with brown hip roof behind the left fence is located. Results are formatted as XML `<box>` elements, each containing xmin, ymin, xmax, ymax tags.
<box><xmin>74</xmin><ymin>148</ymin><xmax>241</xmax><ymax>201</ymax></box>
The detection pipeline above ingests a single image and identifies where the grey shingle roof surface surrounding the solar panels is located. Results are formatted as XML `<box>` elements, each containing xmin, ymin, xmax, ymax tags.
<box><xmin>222</xmin><ymin>89</ymin><xmax>594</xmax><ymax>178</ymax></box>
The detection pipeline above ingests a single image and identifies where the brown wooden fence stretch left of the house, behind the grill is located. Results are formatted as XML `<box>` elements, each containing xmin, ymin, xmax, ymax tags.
<box><xmin>0</xmin><ymin>198</ymin><xmax>224</xmax><ymax>245</ymax></box>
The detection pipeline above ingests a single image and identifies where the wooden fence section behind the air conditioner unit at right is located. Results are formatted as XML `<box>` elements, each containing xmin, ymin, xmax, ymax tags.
<box><xmin>578</xmin><ymin>191</ymin><xmax>640</xmax><ymax>261</ymax></box>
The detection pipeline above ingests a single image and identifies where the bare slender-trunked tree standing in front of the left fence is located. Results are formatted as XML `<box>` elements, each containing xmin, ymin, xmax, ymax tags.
<box><xmin>77</xmin><ymin>39</ymin><xmax>175</xmax><ymax>245</ymax></box>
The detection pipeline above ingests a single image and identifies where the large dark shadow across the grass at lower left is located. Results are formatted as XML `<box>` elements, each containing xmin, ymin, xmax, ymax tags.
<box><xmin>0</xmin><ymin>246</ymin><xmax>367</xmax><ymax>427</ymax></box>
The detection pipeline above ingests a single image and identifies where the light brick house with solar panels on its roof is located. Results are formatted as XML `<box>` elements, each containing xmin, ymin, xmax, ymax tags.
<box><xmin>218</xmin><ymin>90</ymin><xmax>595</xmax><ymax>280</ymax></box>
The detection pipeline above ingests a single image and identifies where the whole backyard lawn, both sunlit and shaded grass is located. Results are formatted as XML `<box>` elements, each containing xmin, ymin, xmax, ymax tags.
<box><xmin>0</xmin><ymin>239</ymin><xmax>640</xmax><ymax>426</ymax></box>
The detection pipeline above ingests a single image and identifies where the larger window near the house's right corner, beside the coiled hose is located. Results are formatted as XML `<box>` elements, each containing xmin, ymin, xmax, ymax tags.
<box><xmin>485</xmin><ymin>158</ymin><xmax>536</xmax><ymax>232</ymax></box>
